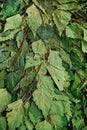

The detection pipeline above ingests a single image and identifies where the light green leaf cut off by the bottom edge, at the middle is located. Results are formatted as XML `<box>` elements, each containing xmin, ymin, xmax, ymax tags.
<box><xmin>36</xmin><ymin>120</ymin><xmax>53</xmax><ymax>130</ymax></box>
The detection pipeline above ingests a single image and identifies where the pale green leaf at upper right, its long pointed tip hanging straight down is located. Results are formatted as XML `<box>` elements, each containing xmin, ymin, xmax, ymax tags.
<box><xmin>53</xmin><ymin>10</ymin><xmax>71</xmax><ymax>36</ymax></box>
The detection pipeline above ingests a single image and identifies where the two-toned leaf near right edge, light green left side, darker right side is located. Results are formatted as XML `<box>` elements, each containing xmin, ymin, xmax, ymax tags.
<box><xmin>66</xmin><ymin>23</ymin><xmax>83</xmax><ymax>39</ymax></box>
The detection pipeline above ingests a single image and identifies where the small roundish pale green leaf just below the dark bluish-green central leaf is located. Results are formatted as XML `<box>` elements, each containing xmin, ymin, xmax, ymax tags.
<box><xmin>32</xmin><ymin>40</ymin><xmax>47</xmax><ymax>56</ymax></box>
